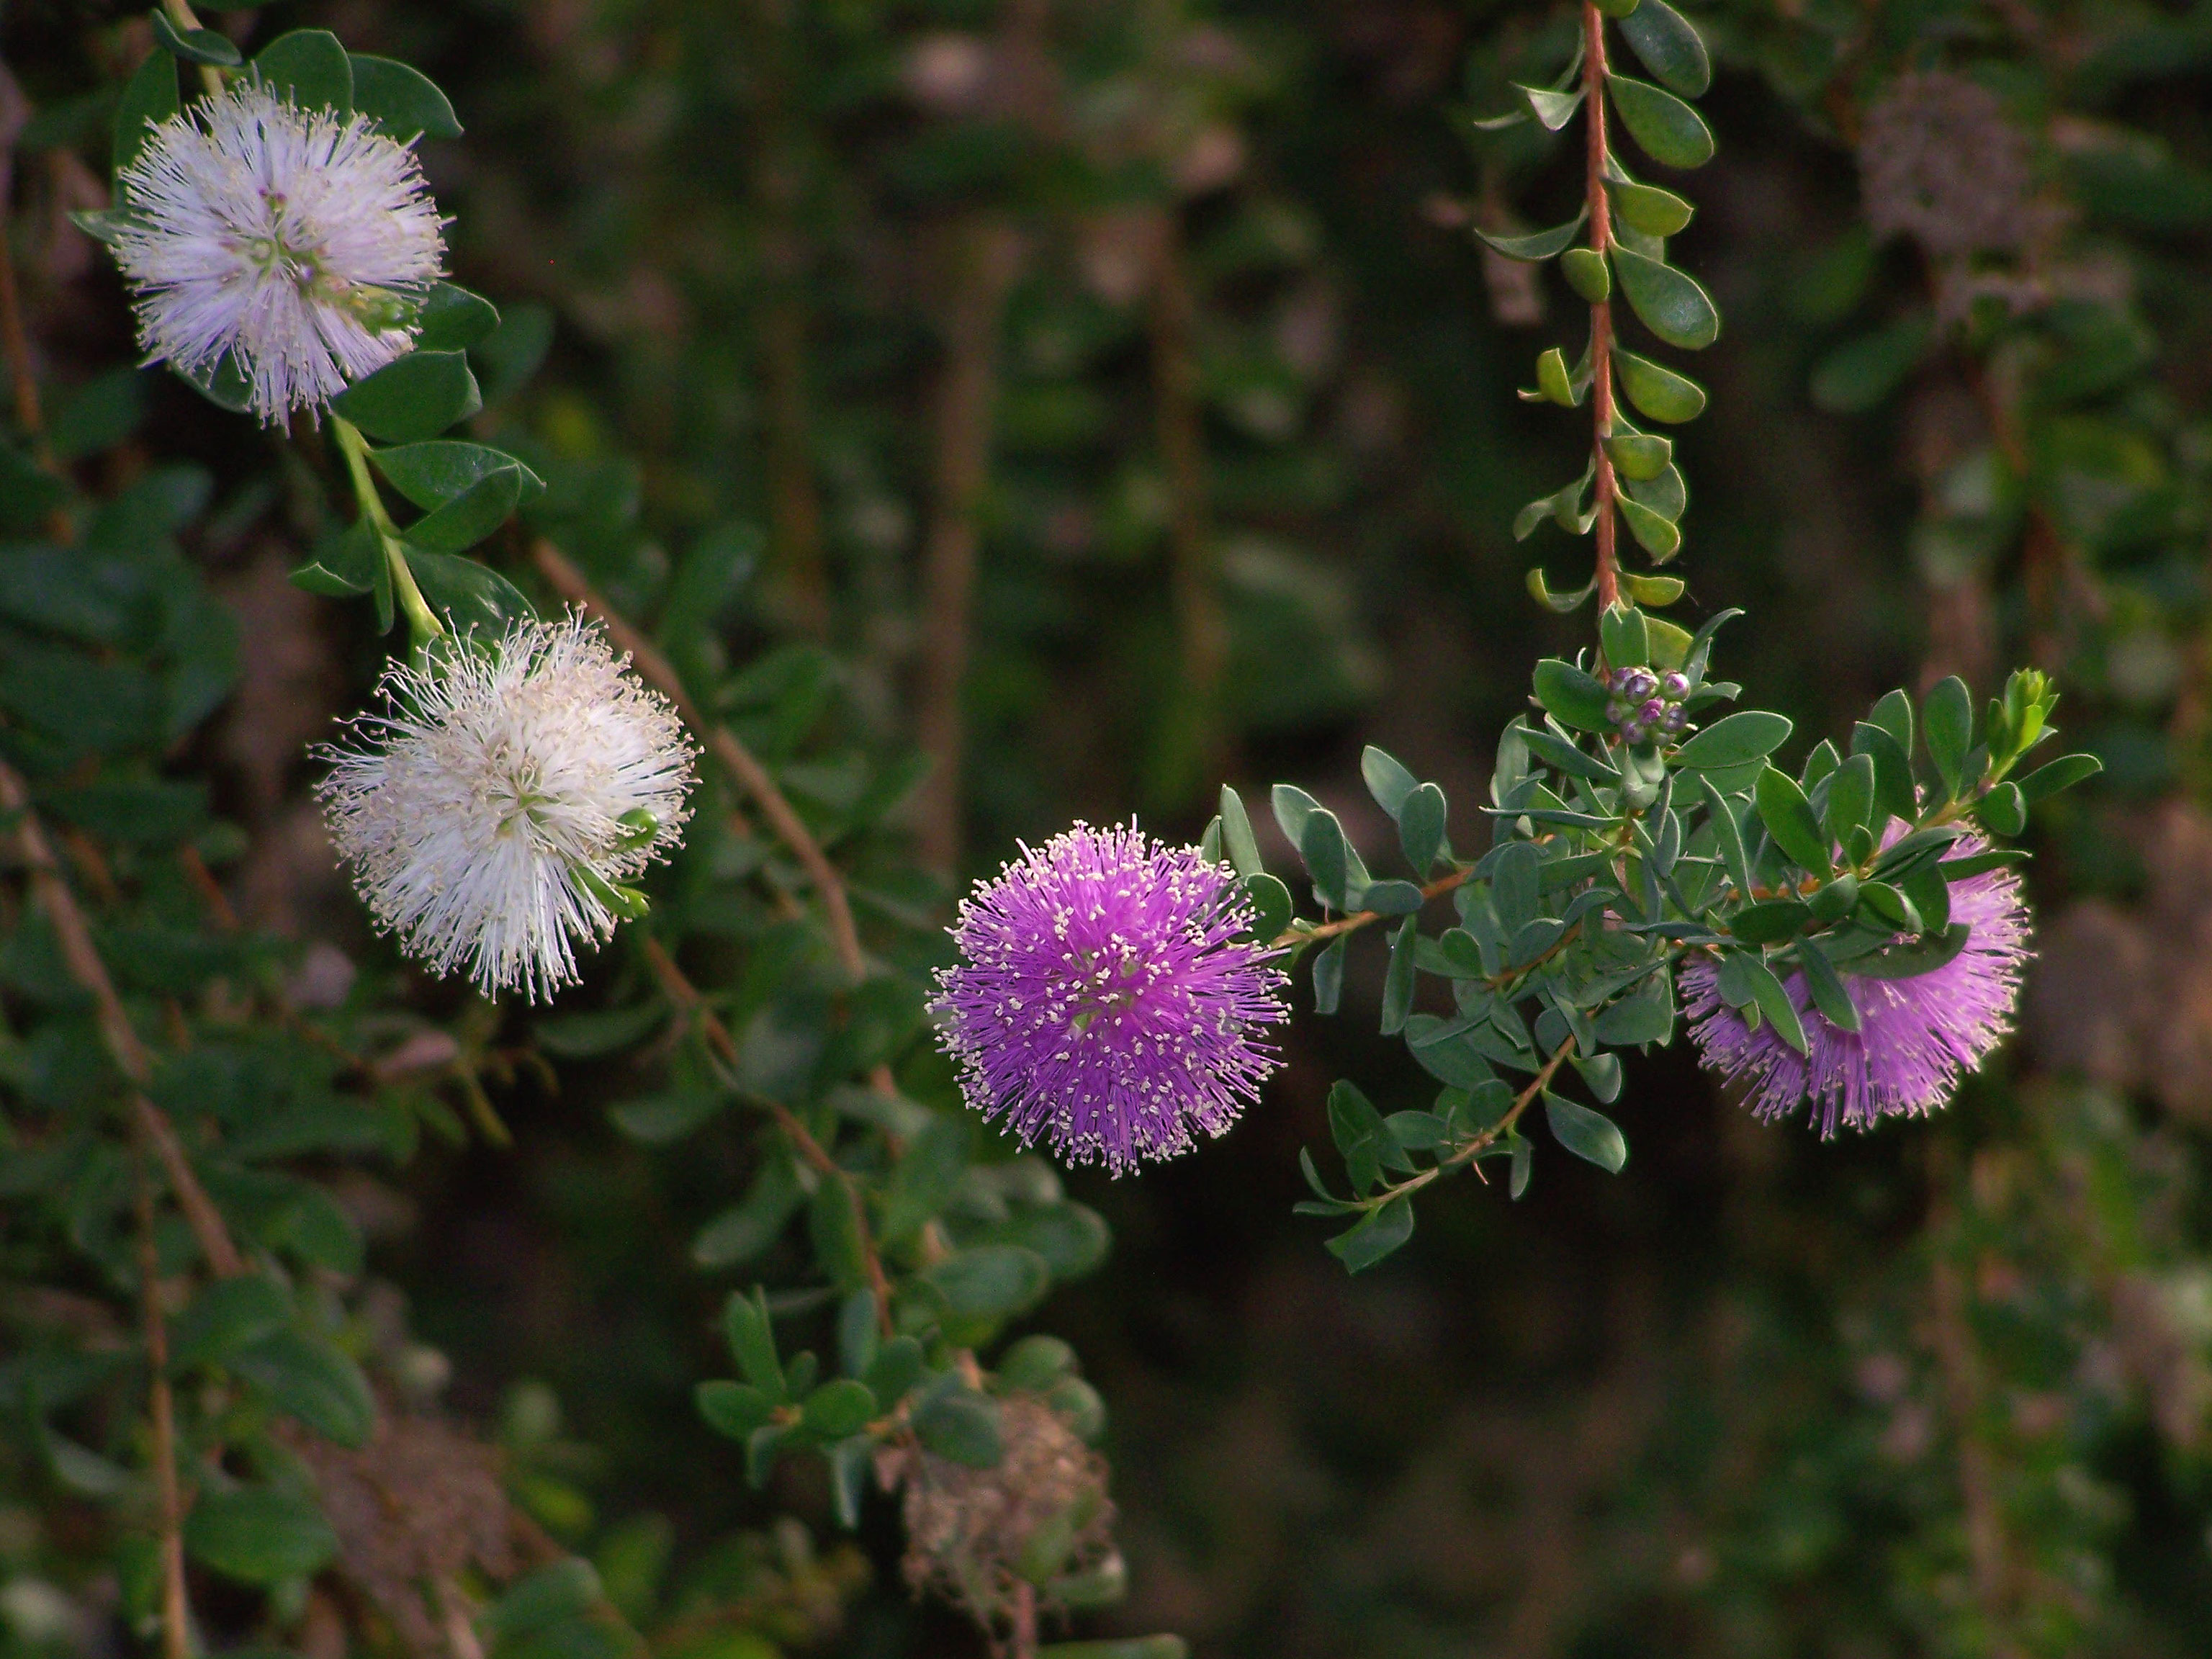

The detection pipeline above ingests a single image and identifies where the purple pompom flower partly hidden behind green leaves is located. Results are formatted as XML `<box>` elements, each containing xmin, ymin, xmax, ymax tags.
<box><xmin>1681</xmin><ymin>836</ymin><xmax>2028</xmax><ymax>1139</ymax></box>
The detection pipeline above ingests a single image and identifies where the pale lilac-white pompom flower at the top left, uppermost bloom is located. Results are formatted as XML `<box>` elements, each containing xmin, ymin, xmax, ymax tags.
<box><xmin>113</xmin><ymin>80</ymin><xmax>444</xmax><ymax>425</ymax></box>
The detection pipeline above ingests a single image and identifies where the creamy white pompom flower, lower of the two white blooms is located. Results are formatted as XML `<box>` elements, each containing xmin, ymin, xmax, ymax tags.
<box><xmin>316</xmin><ymin>615</ymin><xmax>697</xmax><ymax>1000</ymax></box>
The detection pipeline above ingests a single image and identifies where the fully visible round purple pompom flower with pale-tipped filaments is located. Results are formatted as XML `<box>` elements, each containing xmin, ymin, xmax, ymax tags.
<box><xmin>929</xmin><ymin>823</ymin><xmax>1287</xmax><ymax>1174</ymax></box>
